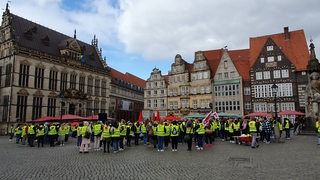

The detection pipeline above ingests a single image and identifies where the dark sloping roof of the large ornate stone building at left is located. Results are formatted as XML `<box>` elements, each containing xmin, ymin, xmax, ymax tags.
<box><xmin>10</xmin><ymin>14</ymin><xmax>105</xmax><ymax>69</ymax></box>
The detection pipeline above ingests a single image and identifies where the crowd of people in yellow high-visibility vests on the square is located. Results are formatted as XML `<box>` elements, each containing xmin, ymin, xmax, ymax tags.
<box><xmin>10</xmin><ymin>117</ymin><xmax>320</xmax><ymax>153</ymax></box>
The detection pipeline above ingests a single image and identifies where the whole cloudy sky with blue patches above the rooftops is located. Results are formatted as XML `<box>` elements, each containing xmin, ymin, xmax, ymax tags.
<box><xmin>0</xmin><ymin>0</ymin><xmax>320</xmax><ymax>79</ymax></box>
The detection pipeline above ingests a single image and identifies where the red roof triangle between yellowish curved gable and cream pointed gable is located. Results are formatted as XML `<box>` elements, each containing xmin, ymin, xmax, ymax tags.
<box><xmin>203</xmin><ymin>49</ymin><xmax>223</xmax><ymax>76</ymax></box>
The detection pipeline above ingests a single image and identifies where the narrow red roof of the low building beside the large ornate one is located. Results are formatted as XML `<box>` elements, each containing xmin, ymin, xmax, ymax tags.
<box><xmin>111</xmin><ymin>68</ymin><xmax>146</xmax><ymax>88</ymax></box>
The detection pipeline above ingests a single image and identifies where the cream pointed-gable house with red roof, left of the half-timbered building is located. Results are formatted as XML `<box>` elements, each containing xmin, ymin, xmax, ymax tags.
<box><xmin>207</xmin><ymin>49</ymin><xmax>251</xmax><ymax>116</ymax></box>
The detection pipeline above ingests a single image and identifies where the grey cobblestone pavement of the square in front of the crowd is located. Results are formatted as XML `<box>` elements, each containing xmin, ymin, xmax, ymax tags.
<box><xmin>0</xmin><ymin>135</ymin><xmax>320</xmax><ymax>180</ymax></box>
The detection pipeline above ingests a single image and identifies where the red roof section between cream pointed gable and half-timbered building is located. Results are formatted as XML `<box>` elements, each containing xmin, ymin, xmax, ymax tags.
<box><xmin>228</xmin><ymin>49</ymin><xmax>250</xmax><ymax>81</ymax></box>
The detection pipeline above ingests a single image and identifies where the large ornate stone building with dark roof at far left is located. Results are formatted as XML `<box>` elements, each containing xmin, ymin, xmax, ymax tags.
<box><xmin>0</xmin><ymin>6</ymin><xmax>110</xmax><ymax>133</ymax></box>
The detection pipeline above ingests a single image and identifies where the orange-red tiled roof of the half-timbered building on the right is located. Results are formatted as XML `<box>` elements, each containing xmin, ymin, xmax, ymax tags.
<box><xmin>250</xmin><ymin>30</ymin><xmax>309</xmax><ymax>71</ymax></box>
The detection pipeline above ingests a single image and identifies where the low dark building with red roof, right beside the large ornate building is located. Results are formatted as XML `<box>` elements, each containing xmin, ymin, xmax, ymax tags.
<box><xmin>109</xmin><ymin>68</ymin><xmax>146</xmax><ymax>121</ymax></box>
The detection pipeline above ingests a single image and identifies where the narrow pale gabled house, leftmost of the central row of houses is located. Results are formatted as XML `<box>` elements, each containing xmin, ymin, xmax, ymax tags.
<box><xmin>143</xmin><ymin>68</ymin><xmax>168</xmax><ymax>119</ymax></box>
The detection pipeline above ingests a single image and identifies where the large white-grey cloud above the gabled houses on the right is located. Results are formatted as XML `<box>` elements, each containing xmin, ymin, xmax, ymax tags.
<box><xmin>118</xmin><ymin>0</ymin><xmax>320</xmax><ymax>59</ymax></box>
